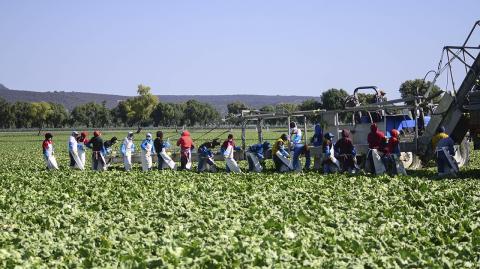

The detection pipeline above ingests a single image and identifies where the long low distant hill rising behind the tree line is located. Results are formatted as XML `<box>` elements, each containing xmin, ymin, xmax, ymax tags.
<box><xmin>0</xmin><ymin>84</ymin><xmax>320</xmax><ymax>113</ymax></box>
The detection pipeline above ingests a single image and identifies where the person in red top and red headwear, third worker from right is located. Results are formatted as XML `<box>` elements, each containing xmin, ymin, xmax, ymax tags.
<box><xmin>365</xmin><ymin>123</ymin><xmax>386</xmax><ymax>175</ymax></box>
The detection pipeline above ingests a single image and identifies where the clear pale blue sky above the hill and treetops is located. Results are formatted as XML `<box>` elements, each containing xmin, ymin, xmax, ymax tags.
<box><xmin>0</xmin><ymin>0</ymin><xmax>480</xmax><ymax>98</ymax></box>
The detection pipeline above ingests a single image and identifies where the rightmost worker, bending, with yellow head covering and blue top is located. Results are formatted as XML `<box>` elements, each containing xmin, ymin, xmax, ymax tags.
<box><xmin>432</xmin><ymin>126</ymin><xmax>459</xmax><ymax>177</ymax></box>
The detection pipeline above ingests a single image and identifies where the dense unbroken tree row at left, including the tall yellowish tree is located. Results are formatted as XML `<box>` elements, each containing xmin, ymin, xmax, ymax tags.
<box><xmin>0</xmin><ymin>85</ymin><xmax>221</xmax><ymax>129</ymax></box>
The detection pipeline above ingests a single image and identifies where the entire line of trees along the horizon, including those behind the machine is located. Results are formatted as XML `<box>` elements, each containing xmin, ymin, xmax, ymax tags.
<box><xmin>0</xmin><ymin>80</ymin><xmax>440</xmax><ymax>129</ymax></box>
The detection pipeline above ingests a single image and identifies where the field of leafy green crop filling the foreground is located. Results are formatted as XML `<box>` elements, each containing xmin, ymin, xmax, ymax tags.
<box><xmin>0</xmin><ymin>132</ymin><xmax>480</xmax><ymax>268</ymax></box>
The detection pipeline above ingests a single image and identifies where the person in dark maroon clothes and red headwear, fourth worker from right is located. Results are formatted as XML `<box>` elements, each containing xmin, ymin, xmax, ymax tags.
<box><xmin>334</xmin><ymin>129</ymin><xmax>357</xmax><ymax>173</ymax></box>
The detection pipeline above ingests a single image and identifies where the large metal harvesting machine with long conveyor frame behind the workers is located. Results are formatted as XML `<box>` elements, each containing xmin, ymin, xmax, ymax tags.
<box><xmin>241</xmin><ymin>21</ymin><xmax>480</xmax><ymax>169</ymax></box>
